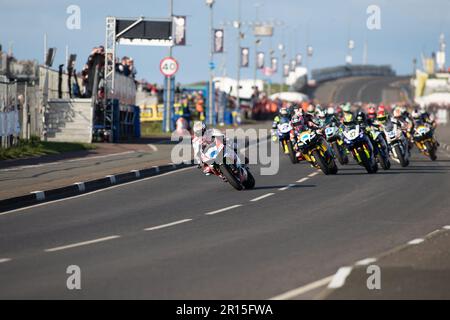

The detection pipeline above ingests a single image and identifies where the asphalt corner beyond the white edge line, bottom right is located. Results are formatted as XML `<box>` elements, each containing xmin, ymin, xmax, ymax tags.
<box><xmin>322</xmin><ymin>226</ymin><xmax>450</xmax><ymax>300</ymax></box>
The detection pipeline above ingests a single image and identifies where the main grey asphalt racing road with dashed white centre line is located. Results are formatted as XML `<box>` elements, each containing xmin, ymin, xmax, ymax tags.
<box><xmin>0</xmin><ymin>128</ymin><xmax>450</xmax><ymax>299</ymax></box>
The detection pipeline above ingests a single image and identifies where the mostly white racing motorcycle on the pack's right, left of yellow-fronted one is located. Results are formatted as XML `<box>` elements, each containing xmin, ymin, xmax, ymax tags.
<box><xmin>384</xmin><ymin>121</ymin><xmax>409</xmax><ymax>167</ymax></box>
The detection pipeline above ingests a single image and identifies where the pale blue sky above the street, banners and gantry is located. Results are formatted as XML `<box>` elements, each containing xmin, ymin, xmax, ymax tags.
<box><xmin>0</xmin><ymin>0</ymin><xmax>450</xmax><ymax>83</ymax></box>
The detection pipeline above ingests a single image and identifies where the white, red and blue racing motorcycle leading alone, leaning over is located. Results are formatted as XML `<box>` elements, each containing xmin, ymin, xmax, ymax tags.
<box><xmin>201</xmin><ymin>132</ymin><xmax>255</xmax><ymax>190</ymax></box>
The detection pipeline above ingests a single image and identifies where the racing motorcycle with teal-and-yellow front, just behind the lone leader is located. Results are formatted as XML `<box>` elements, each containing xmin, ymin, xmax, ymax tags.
<box><xmin>297</xmin><ymin>130</ymin><xmax>338</xmax><ymax>175</ymax></box>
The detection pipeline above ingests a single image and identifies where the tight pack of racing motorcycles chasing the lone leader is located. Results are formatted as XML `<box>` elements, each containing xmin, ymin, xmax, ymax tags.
<box><xmin>276</xmin><ymin>110</ymin><xmax>437</xmax><ymax>175</ymax></box>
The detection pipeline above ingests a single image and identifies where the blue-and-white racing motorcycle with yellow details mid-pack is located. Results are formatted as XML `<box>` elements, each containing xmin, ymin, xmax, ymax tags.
<box><xmin>342</xmin><ymin>125</ymin><xmax>378</xmax><ymax>173</ymax></box>
